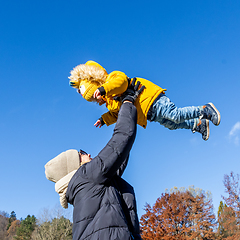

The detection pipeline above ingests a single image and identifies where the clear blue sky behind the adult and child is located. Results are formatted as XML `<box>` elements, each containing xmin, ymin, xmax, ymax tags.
<box><xmin>0</xmin><ymin>0</ymin><xmax>240</xmax><ymax>218</ymax></box>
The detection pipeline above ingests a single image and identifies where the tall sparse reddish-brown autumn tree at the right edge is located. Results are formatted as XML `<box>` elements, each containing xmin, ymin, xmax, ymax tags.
<box><xmin>218</xmin><ymin>172</ymin><xmax>240</xmax><ymax>240</ymax></box>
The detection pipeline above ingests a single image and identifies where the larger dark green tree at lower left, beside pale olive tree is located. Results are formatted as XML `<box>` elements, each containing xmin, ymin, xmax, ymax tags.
<box><xmin>15</xmin><ymin>215</ymin><xmax>36</xmax><ymax>240</ymax></box>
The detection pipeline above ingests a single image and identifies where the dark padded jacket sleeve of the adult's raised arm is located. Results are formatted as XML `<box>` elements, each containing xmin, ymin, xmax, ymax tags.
<box><xmin>79</xmin><ymin>102</ymin><xmax>137</xmax><ymax>184</ymax></box>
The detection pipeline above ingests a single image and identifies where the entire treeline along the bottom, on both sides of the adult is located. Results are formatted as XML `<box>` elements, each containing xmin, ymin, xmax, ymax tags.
<box><xmin>0</xmin><ymin>172</ymin><xmax>240</xmax><ymax>240</ymax></box>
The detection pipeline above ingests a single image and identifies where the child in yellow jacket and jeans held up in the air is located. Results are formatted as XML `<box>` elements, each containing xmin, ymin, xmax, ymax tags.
<box><xmin>69</xmin><ymin>61</ymin><xmax>221</xmax><ymax>141</ymax></box>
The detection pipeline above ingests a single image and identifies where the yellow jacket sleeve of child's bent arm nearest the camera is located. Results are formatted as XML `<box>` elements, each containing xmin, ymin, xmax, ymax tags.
<box><xmin>102</xmin><ymin>71</ymin><xmax>128</xmax><ymax>97</ymax></box>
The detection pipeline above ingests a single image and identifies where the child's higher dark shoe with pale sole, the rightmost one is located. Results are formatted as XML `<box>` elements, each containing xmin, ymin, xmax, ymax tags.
<box><xmin>200</xmin><ymin>103</ymin><xmax>221</xmax><ymax>126</ymax></box>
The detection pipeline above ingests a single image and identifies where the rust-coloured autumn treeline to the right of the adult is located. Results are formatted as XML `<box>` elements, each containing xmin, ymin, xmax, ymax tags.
<box><xmin>140</xmin><ymin>172</ymin><xmax>240</xmax><ymax>240</ymax></box>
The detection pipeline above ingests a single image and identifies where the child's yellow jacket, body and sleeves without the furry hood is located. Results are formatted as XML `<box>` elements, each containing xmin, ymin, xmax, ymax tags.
<box><xmin>102</xmin><ymin>71</ymin><xmax>166</xmax><ymax>128</ymax></box>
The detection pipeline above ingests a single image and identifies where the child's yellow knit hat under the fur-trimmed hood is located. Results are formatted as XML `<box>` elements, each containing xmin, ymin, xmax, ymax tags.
<box><xmin>79</xmin><ymin>80</ymin><xmax>100</xmax><ymax>102</ymax></box>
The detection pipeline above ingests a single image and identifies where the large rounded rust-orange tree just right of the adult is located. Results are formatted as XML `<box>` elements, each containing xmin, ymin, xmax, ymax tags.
<box><xmin>140</xmin><ymin>188</ymin><xmax>216</xmax><ymax>240</ymax></box>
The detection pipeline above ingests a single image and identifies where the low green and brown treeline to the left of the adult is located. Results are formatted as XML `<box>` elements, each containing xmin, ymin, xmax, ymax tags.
<box><xmin>0</xmin><ymin>209</ymin><xmax>72</xmax><ymax>240</ymax></box>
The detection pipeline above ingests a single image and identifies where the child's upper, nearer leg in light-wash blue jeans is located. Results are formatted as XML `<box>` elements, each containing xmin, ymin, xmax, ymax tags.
<box><xmin>150</xmin><ymin>95</ymin><xmax>202</xmax><ymax>124</ymax></box>
